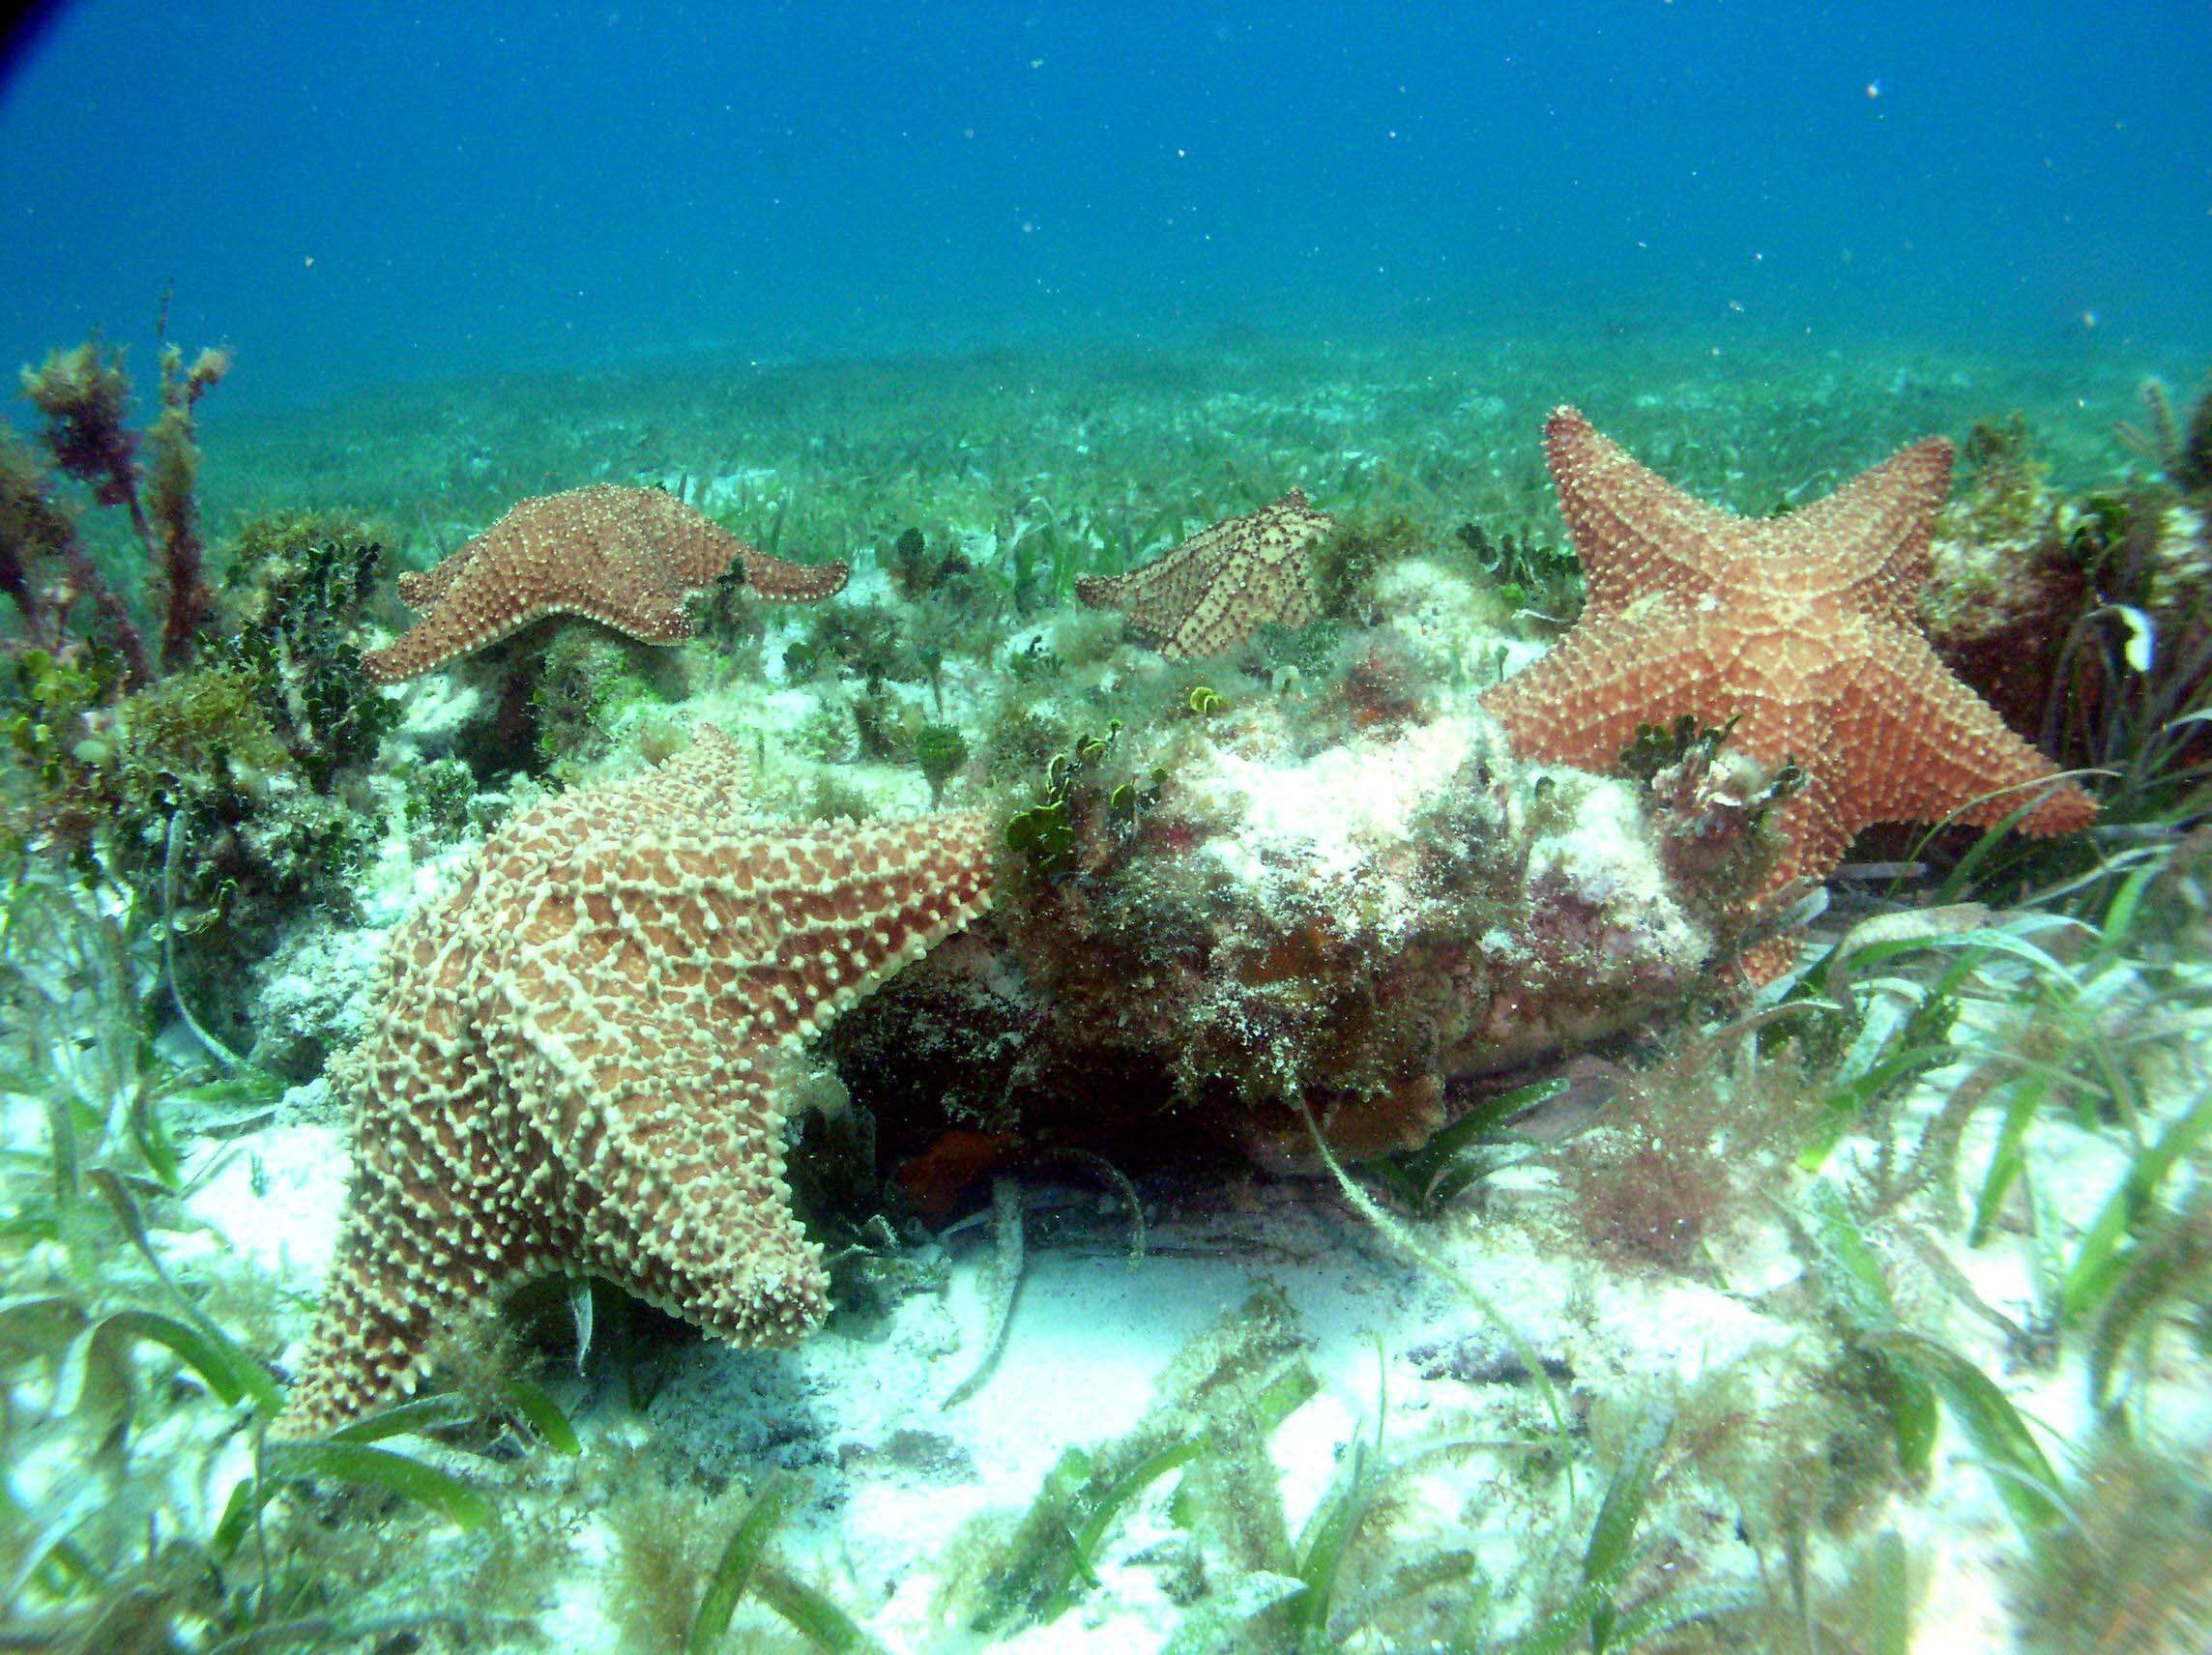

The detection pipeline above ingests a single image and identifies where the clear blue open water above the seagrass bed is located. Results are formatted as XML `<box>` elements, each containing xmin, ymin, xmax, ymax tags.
<box><xmin>0</xmin><ymin>0</ymin><xmax>2212</xmax><ymax>407</ymax></box>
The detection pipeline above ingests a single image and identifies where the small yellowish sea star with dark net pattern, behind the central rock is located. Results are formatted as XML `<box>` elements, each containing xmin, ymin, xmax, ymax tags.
<box><xmin>1075</xmin><ymin>489</ymin><xmax>1336</xmax><ymax>661</ymax></box>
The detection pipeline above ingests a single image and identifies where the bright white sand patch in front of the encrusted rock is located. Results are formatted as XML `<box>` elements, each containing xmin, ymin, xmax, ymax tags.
<box><xmin>615</xmin><ymin>1159</ymin><xmax>1857</xmax><ymax>1650</ymax></box>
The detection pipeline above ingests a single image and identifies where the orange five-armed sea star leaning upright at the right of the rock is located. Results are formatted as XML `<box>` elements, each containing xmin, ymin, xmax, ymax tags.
<box><xmin>1482</xmin><ymin>407</ymin><xmax>2097</xmax><ymax>978</ymax></box>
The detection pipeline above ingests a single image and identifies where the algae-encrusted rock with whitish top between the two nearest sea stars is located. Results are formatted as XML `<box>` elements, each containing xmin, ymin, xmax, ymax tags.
<box><xmin>834</xmin><ymin>702</ymin><xmax>1754</xmax><ymax>1200</ymax></box>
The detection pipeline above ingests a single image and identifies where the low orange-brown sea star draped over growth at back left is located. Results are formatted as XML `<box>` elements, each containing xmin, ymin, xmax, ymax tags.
<box><xmin>361</xmin><ymin>482</ymin><xmax>847</xmax><ymax>683</ymax></box>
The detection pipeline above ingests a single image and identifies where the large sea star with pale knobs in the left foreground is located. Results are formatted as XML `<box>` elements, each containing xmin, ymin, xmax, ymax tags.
<box><xmin>275</xmin><ymin>730</ymin><xmax>993</xmax><ymax>1438</ymax></box>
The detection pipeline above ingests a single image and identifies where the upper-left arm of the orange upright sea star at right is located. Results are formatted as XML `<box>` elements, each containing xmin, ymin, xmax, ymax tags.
<box><xmin>1544</xmin><ymin>407</ymin><xmax>1748</xmax><ymax>620</ymax></box>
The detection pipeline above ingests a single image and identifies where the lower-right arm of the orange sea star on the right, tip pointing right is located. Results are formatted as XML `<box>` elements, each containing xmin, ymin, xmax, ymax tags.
<box><xmin>1829</xmin><ymin>626</ymin><xmax>2097</xmax><ymax>834</ymax></box>
